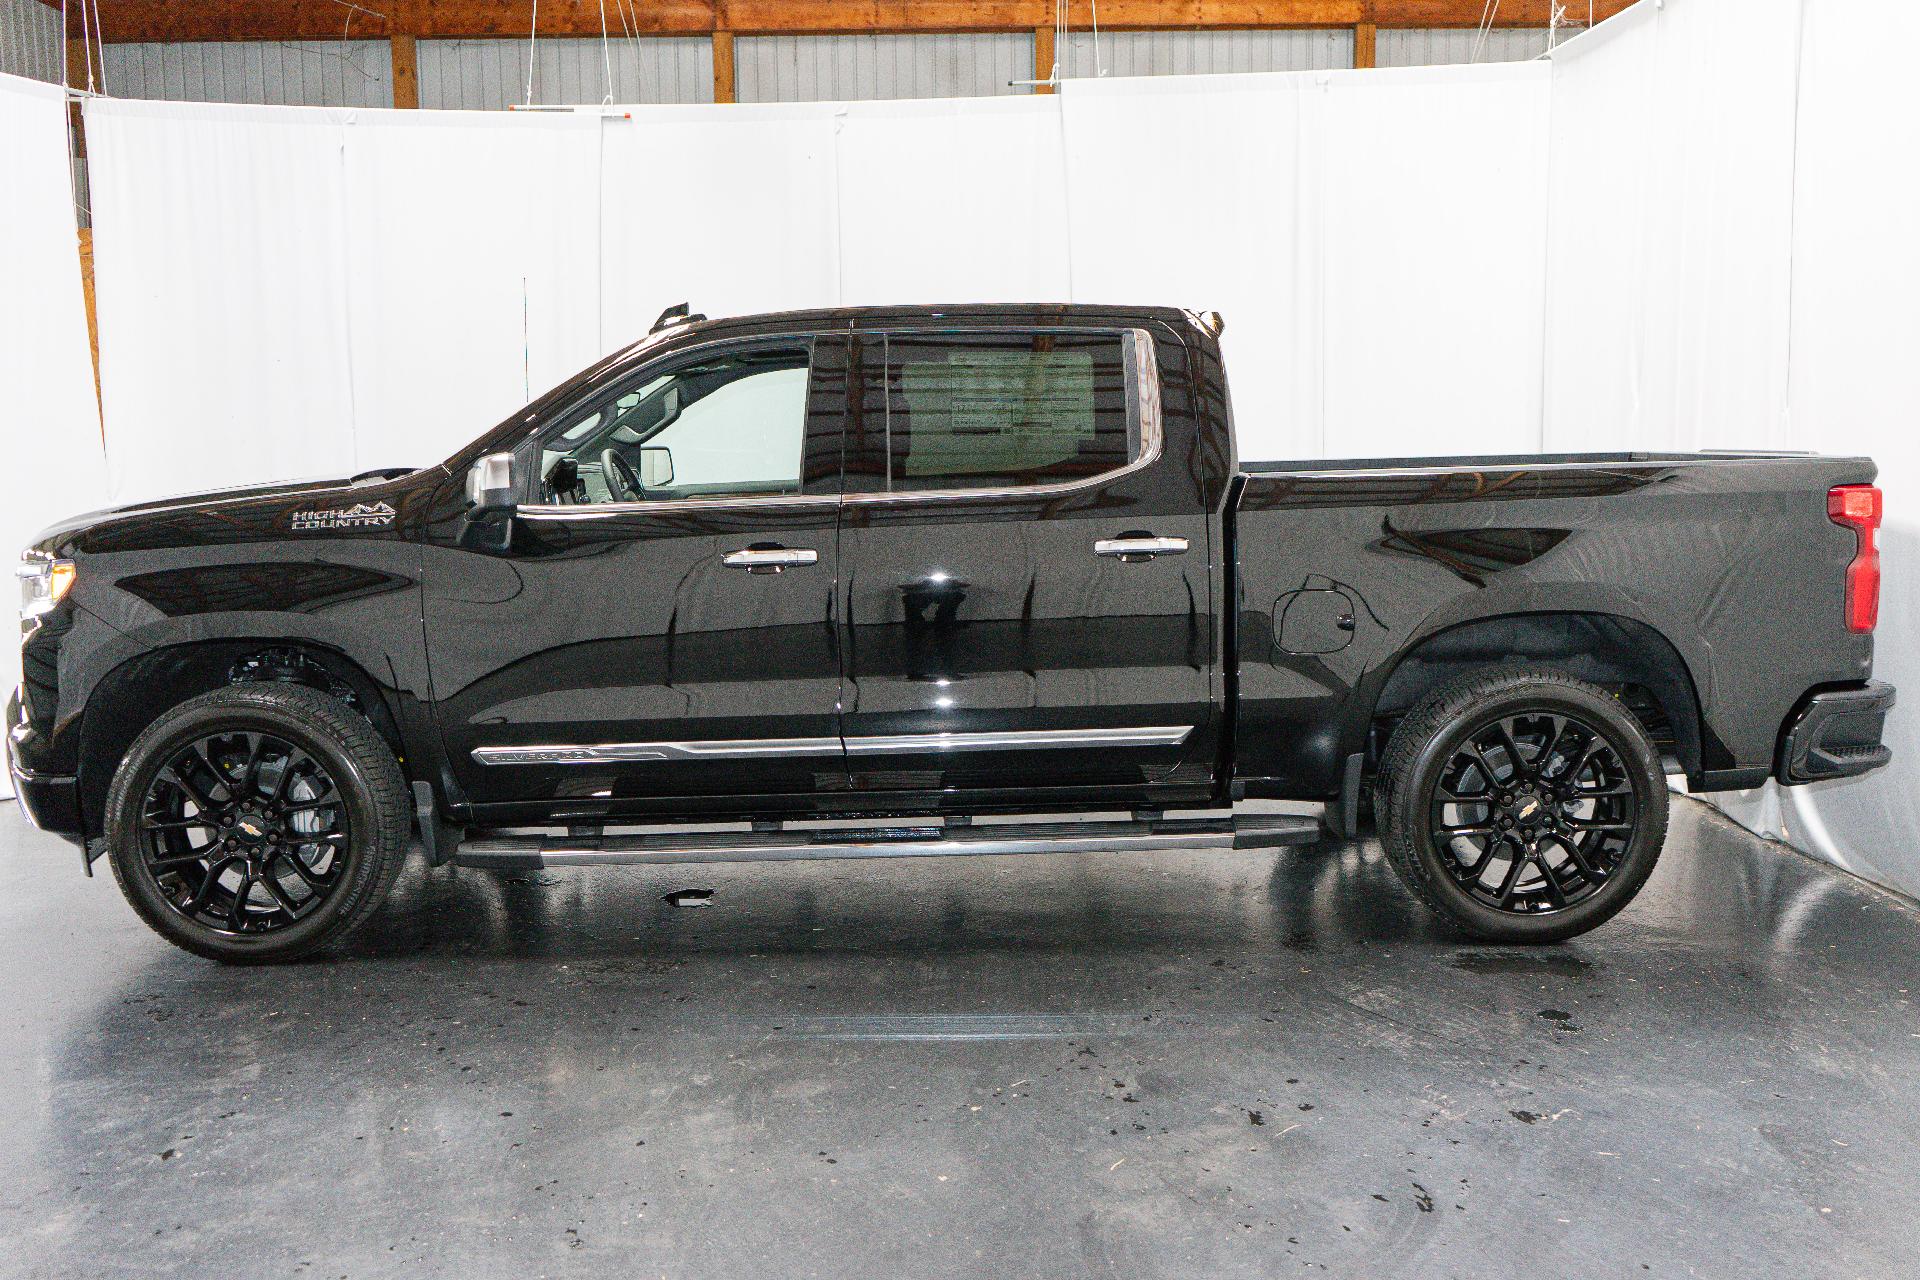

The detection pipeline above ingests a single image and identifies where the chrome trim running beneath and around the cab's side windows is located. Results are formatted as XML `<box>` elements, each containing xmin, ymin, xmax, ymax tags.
<box><xmin>516</xmin><ymin>324</ymin><xmax>1165</xmax><ymax>520</ymax></box>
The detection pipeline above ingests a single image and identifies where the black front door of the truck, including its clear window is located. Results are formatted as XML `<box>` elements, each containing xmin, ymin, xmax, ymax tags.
<box><xmin>426</xmin><ymin>336</ymin><xmax>847</xmax><ymax>821</ymax></box>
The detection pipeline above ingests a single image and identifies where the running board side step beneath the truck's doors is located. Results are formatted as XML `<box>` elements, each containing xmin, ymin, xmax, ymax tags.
<box><xmin>453</xmin><ymin>814</ymin><xmax>1325</xmax><ymax>871</ymax></box>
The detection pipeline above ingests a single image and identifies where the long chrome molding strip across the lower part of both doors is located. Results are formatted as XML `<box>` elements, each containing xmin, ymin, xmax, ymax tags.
<box><xmin>468</xmin><ymin>725</ymin><xmax>1194</xmax><ymax>764</ymax></box>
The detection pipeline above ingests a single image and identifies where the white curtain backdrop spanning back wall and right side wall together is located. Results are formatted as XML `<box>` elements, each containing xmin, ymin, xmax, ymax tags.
<box><xmin>52</xmin><ymin>0</ymin><xmax>1920</xmax><ymax>892</ymax></box>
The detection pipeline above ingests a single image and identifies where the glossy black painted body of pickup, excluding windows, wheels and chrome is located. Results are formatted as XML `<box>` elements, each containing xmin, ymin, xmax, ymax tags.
<box><xmin>13</xmin><ymin>307</ymin><xmax>1874</xmax><ymax>855</ymax></box>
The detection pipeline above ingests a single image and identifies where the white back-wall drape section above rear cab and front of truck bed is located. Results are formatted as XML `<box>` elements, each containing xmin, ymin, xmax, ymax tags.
<box><xmin>1062</xmin><ymin>63</ymin><xmax>1549</xmax><ymax>459</ymax></box>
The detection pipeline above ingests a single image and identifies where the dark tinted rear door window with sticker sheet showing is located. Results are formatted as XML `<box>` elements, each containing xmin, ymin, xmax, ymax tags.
<box><xmin>866</xmin><ymin>332</ymin><xmax>1137</xmax><ymax>493</ymax></box>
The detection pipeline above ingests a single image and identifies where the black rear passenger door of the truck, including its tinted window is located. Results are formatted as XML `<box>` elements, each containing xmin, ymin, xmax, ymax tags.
<box><xmin>841</xmin><ymin>326</ymin><xmax>1215</xmax><ymax>804</ymax></box>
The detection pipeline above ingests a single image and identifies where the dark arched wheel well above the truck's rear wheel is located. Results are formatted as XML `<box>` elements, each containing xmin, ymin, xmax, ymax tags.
<box><xmin>1367</xmin><ymin>612</ymin><xmax>1701</xmax><ymax>783</ymax></box>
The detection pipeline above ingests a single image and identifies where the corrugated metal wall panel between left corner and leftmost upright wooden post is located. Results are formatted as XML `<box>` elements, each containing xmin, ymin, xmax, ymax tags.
<box><xmin>104</xmin><ymin>40</ymin><xmax>394</xmax><ymax>107</ymax></box>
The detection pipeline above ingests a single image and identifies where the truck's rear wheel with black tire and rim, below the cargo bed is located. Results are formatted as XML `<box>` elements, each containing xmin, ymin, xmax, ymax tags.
<box><xmin>1375</xmin><ymin>670</ymin><xmax>1667</xmax><ymax>942</ymax></box>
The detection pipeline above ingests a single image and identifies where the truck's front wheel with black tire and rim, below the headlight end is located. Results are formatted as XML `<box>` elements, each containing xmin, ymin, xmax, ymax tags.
<box><xmin>106</xmin><ymin>683</ymin><xmax>411</xmax><ymax>963</ymax></box>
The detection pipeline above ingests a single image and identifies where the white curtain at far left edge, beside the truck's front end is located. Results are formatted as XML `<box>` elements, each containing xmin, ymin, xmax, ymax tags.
<box><xmin>0</xmin><ymin>75</ymin><xmax>106</xmax><ymax>796</ymax></box>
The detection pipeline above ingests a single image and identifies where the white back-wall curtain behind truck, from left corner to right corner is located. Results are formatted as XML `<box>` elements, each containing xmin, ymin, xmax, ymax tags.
<box><xmin>86</xmin><ymin>63</ymin><xmax>1549</xmax><ymax>499</ymax></box>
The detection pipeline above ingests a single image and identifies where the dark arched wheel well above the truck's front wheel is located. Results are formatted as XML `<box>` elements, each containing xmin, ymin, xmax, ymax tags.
<box><xmin>79</xmin><ymin>639</ymin><xmax>405</xmax><ymax>835</ymax></box>
